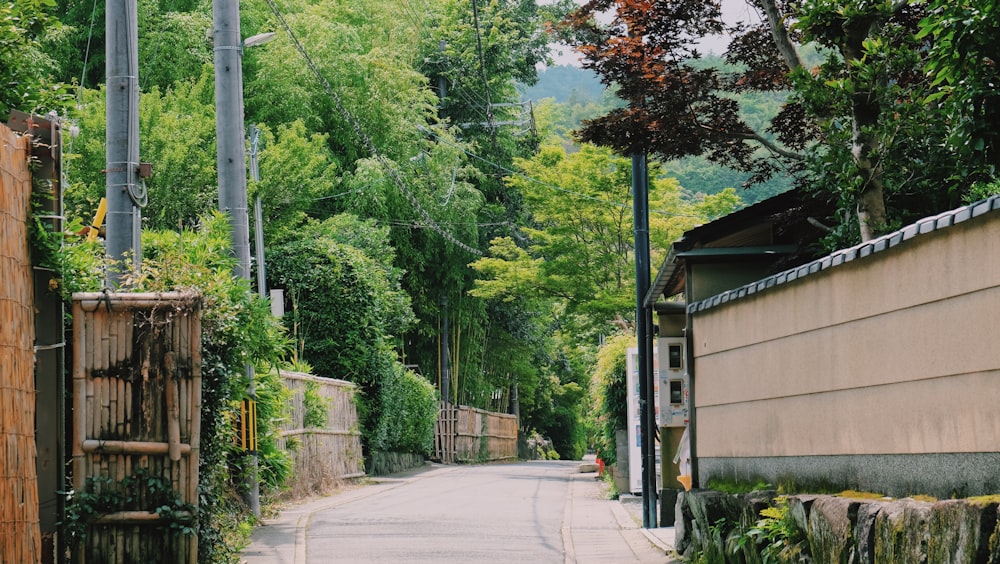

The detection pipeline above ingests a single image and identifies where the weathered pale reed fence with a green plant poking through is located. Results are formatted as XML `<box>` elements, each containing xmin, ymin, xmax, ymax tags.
<box><xmin>277</xmin><ymin>372</ymin><xmax>365</xmax><ymax>498</ymax></box>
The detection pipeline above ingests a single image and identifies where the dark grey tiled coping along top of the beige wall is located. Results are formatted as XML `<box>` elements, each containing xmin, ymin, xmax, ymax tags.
<box><xmin>688</xmin><ymin>195</ymin><xmax>1000</xmax><ymax>313</ymax></box>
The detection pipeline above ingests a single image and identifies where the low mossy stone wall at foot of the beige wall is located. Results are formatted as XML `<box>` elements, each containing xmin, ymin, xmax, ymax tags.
<box><xmin>674</xmin><ymin>490</ymin><xmax>1000</xmax><ymax>564</ymax></box>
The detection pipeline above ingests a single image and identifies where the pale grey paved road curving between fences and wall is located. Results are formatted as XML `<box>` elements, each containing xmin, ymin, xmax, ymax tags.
<box><xmin>242</xmin><ymin>461</ymin><xmax>669</xmax><ymax>564</ymax></box>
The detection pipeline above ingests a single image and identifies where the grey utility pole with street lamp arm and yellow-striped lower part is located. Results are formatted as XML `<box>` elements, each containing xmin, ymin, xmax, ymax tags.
<box><xmin>212</xmin><ymin>0</ymin><xmax>260</xmax><ymax>517</ymax></box>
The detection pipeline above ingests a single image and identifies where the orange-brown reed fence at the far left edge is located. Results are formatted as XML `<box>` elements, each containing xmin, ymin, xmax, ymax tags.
<box><xmin>0</xmin><ymin>121</ymin><xmax>41</xmax><ymax>562</ymax></box>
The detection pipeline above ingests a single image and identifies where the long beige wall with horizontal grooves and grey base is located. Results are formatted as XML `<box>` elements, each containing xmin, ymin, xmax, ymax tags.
<box><xmin>690</xmin><ymin>203</ymin><xmax>1000</xmax><ymax>496</ymax></box>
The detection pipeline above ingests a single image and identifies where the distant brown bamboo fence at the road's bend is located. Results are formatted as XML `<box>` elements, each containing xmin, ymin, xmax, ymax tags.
<box><xmin>434</xmin><ymin>403</ymin><xmax>517</xmax><ymax>463</ymax></box>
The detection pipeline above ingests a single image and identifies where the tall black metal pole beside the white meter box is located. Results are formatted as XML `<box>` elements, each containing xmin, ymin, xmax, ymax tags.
<box><xmin>632</xmin><ymin>152</ymin><xmax>656</xmax><ymax>529</ymax></box>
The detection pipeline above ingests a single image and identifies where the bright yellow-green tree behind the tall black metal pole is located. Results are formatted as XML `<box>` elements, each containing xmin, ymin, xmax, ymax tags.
<box><xmin>472</xmin><ymin>145</ymin><xmax>739</xmax><ymax>334</ymax></box>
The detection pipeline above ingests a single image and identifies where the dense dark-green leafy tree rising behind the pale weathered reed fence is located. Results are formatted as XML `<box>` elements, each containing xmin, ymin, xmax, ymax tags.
<box><xmin>268</xmin><ymin>215</ymin><xmax>413</xmax><ymax>454</ymax></box>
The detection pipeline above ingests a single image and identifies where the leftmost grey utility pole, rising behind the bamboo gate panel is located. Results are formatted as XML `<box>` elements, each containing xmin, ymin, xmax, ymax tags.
<box><xmin>104</xmin><ymin>0</ymin><xmax>145</xmax><ymax>278</ymax></box>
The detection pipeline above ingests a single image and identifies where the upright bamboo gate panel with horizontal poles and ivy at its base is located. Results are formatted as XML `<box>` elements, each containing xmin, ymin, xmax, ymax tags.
<box><xmin>70</xmin><ymin>293</ymin><xmax>201</xmax><ymax>563</ymax></box>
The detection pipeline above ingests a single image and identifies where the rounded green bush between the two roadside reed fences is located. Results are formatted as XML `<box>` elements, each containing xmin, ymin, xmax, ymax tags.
<box><xmin>373</xmin><ymin>364</ymin><xmax>438</xmax><ymax>456</ymax></box>
